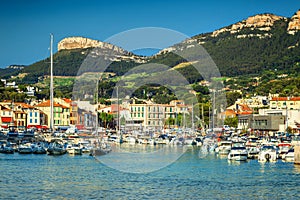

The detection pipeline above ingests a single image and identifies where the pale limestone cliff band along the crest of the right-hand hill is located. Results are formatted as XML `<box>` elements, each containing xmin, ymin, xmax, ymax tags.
<box><xmin>212</xmin><ymin>14</ymin><xmax>286</xmax><ymax>37</ymax></box>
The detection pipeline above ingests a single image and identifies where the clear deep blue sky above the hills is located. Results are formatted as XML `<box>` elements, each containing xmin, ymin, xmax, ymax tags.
<box><xmin>0</xmin><ymin>0</ymin><xmax>300</xmax><ymax>67</ymax></box>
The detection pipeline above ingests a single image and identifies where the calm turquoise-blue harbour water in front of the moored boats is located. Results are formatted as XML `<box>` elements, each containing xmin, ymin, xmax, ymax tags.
<box><xmin>0</xmin><ymin>148</ymin><xmax>300</xmax><ymax>199</ymax></box>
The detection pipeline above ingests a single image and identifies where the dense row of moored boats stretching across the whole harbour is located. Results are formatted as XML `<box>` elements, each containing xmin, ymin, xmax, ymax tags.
<box><xmin>0</xmin><ymin>128</ymin><xmax>300</xmax><ymax>162</ymax></box>
